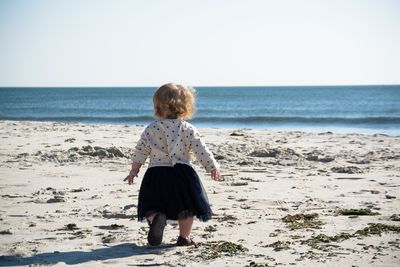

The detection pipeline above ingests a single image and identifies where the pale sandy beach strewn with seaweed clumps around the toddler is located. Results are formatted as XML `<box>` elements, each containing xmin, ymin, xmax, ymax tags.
<box><xmin>0</xmin><ymin>121</ymin><xmax>400</xmax><ymax>267</ymax></box>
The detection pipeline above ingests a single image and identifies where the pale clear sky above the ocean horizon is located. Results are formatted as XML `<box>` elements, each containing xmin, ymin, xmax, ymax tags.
<box><xmin>0</xmin><ymin>0</ymin><xmax>400</xmax><ymax>86</ymax></box>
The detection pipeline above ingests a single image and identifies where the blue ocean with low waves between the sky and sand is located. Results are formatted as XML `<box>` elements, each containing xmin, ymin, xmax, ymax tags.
<box><xmin>0</xmin><ymin>85</ymin><xmax>400</xmax><ymax>135</ymax></box>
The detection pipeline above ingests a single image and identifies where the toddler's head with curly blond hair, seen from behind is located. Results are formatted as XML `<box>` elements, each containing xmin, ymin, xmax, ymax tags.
<box><xmin>153</xmin><ymin>83</ymin><xmax>195</xmax><ymax>119</ymax></box>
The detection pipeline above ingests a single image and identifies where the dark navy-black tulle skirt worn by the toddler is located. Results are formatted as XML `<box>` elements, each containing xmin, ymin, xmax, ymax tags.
<box><xmin>138</xmin><ymin>163</ymin><xmax>212</xmax><ymax>221</ymax></box>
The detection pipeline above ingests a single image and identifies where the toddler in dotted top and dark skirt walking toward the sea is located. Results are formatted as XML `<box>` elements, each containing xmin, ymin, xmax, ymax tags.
<box><xmin>124</xmin><ymin>83</ymin><xmax>220</xmax><ymax>246</ymax></box>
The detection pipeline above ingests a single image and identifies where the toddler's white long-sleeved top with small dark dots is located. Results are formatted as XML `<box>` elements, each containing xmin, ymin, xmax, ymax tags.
<box><xmin>132</xmin><ymin>119</ymin><xmax>219</xmax><ymax>172</ymax></box>
